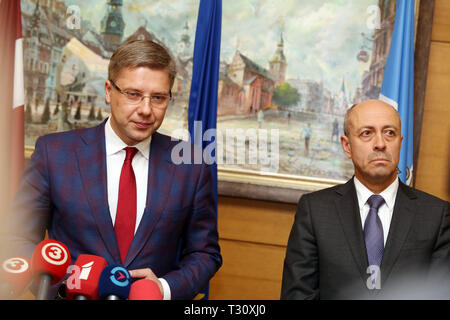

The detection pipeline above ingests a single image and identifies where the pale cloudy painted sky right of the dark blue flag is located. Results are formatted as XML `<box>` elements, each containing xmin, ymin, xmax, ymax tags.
<box><xmin>222</xmin><ymin>0</ymin><xmax>378</xmax><ymax>94</ymax></box>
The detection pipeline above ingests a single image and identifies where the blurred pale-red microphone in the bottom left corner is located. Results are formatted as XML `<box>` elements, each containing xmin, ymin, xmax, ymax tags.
<box><xmin>0</xmin><ymin>257</ymin><xmax>31</xmax><ymax>299</ymax></box>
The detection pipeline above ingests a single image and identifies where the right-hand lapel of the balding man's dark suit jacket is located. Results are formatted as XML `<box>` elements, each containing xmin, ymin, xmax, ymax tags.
<box><xmin>381</xmin><ymin>182</ymin><xmax>417</xmax><ymax>285</ymax></box>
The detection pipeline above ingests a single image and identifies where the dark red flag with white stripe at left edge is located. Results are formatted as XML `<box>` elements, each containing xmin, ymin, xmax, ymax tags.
<box><xmin>0</xmin><ymin>0</ymin><xmax>25</xmax><ymax>193</ymax></box>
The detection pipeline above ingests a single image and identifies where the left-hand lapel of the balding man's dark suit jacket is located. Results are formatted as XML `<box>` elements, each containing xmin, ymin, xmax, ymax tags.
<box><xmin>335</xmin><ymin>179</ymin><xmax>368</xmax><ymax>281</ymax></box>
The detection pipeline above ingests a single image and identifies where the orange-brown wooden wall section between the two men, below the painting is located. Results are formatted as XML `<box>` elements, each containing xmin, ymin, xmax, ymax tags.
<box><xmin>210</xmin><ymin>196</ymin><xmax>296</xmax><ymax>300</ymax></box>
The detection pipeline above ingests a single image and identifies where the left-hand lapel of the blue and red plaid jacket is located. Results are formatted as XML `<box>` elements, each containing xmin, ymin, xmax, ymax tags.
<box><xmin>76</xmin><ymin>121</ymin><xmax>120</xmax><ymax>263</ymax></box>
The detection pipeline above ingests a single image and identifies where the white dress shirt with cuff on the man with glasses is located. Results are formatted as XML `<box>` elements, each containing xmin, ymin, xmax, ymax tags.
<box><xmin>105</xmin><ymin>118</ymin><xmax>171</xmax><ymax>300</ymax></box>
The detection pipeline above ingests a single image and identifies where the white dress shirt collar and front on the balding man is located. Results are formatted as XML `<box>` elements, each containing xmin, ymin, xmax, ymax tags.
<box><xmin>353</xmin><ymin>177</ymin><xmax>399</xmax><ymax>246</ymax></box>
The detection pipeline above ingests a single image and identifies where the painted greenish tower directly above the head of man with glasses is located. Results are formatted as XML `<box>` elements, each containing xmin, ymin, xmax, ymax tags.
<box><xmin>100</xmin><ymin>0</ymin><xmax>125</xmax><ymax>51</ymax></box>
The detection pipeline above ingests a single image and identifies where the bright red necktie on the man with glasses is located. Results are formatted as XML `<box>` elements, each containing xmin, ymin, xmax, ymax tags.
<box><xmin>114</xmin><ymin>147</ymin><xmax>138</xmax><ymax>263</ymax></box>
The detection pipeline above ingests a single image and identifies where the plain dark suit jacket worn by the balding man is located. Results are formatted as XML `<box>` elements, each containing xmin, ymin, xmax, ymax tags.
<box><xmin>281</xmin><ymin>179</ymin><xmax>450</xmax><ymax>299</ymax></box>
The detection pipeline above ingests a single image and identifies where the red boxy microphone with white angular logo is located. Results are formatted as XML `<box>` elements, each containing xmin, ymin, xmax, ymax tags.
<box><xmin>66</xmin><ymin>254</ymin><xmax>108</xmax><ymax>300</ymax></box>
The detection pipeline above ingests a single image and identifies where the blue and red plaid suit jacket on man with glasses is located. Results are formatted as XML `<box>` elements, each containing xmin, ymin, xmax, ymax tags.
<box><xmin>7</xmin><ymin>122</ymin><xmax>222</xmax><ymax>299</ymax></box>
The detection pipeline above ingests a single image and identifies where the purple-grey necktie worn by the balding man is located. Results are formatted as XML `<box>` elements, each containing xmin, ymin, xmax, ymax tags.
<box><xmin>364</xmin><ymin>194</ymin><xmax>384</xmax><ymax>267</ymax></box>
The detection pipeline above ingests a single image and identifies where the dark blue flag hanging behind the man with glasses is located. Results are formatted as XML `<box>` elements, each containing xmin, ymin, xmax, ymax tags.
<box><xmin>188</xmin><ymin>0</ymin><xmax>222</xmax><ymax>299</ymax></box>
